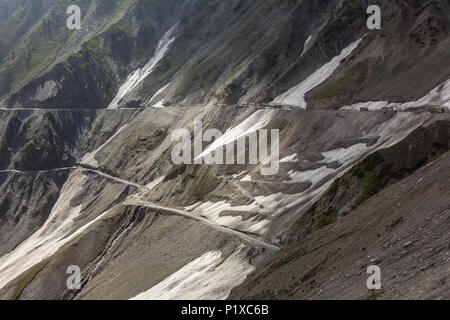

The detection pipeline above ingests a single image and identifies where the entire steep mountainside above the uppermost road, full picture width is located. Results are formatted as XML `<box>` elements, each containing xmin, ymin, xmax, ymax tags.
<box><xmin>0</xmin><ymin>0</ymin><xmax>450</xmax><ymax>108</ymax></box>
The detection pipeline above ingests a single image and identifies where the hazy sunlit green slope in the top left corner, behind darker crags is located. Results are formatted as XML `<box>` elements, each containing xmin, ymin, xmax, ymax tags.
<box><xmin>0</xmin><ymin>0</ymin><xmax>134</xmax><ymax>97</ymax></box>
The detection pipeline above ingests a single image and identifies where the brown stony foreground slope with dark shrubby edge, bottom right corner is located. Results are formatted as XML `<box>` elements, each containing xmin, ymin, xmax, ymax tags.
<box><xmin>230</xmin><ymin>117</ymin><xmax>450</xmax><ymax>300</ymax></box>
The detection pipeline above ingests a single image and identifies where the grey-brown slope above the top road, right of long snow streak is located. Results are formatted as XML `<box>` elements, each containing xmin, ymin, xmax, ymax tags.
<box><xmin>309</xmin><ymin>0</ymin><xmax>450</xmax><ymax>107</ymax></box>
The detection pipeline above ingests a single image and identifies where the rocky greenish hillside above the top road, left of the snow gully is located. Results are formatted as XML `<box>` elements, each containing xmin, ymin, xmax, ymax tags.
<box><xmin>0</xmin><ymin>0</ymin><xmax>186</xmax><ymax>108</ymax></box>
